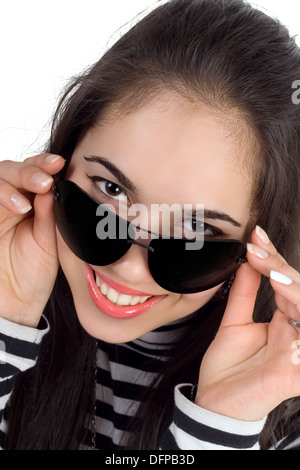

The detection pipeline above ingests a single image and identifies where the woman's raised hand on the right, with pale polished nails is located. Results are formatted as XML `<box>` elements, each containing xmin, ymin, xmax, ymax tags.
<box><xmin>195</xmin><ymin>228</ymin><xmax>300</xmax><ymax>421</ymax></box>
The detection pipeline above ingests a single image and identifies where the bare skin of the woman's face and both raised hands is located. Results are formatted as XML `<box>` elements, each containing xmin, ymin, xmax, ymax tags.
<box><xmin>0</xmin><ymin>93</ymin><xmax>300</xmax><ymax>421</ymax></box>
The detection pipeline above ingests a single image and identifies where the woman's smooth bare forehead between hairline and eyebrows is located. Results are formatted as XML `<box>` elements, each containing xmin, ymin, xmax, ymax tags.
<box><xmin>72</xmin><ymin>96</ymin><xmax>253</xmax><ymax>228</ymax></box>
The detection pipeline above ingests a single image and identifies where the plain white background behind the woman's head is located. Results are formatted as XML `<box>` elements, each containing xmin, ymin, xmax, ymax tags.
<box><xmin>0</xmin><ymin>0</ymin><xmax>300</xmax><ymax>161</ymax></box>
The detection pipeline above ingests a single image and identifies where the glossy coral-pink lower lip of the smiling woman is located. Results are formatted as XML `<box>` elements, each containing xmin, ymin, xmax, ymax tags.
<box><xmin>86</xmin><ymin>264</ymin><xmax>166</xmax><ymax>319</ymax></box>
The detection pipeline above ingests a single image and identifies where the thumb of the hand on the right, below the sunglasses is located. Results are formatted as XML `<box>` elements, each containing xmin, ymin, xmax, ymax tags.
<box><xmin>220</xmin><ymin>263</ymin><xmax>261</xmax><ymax>328</ymax></box>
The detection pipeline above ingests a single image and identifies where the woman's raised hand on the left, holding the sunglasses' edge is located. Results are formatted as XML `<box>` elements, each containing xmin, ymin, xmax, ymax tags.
<box><xmin>0</xmin><ymin>154</ymin><xmax>65</xmax><ymax>327</ymax></box>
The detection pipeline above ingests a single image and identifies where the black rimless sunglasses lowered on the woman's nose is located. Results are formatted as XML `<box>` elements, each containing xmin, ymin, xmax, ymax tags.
<box><xmin>52</xmin><ymin>180</ymin><xmax>247</xmax><ymax>294</ymax></box>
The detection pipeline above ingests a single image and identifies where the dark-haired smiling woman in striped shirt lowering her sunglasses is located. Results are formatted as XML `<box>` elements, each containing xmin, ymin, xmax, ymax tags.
<box><xmin>0</xmin><ymin>0</ymin><xmax>300</xmax><ymax>449</ymax></box>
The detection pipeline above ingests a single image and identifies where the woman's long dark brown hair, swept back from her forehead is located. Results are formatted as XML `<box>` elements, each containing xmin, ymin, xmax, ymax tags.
<box><xmin>6</xmin><ymin>0</ymin><xmax>300</xmax><ymax>449</ymax></box>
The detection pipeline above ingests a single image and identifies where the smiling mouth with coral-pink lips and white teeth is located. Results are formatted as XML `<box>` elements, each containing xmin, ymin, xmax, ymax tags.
<box><xmin>86</xmin><ymin>264</ymin><xmax>166</xmax><ymax>319</ymax></box>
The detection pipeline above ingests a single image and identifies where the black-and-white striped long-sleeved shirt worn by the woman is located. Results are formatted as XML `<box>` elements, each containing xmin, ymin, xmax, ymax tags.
<box><xmin>0</xmin><ymin>318</ymin><xmax>272</xmax><ymax>450</ymax></box>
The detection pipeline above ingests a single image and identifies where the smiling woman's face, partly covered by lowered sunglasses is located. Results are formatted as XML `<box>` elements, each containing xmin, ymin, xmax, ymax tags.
<box><xmin>57</xmin><ymin>95</ymin><xmax>252</xmax><ymax>343</ymax></box>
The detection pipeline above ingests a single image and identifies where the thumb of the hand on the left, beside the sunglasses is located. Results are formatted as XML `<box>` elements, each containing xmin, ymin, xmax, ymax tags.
<box><xmin>33</xmin><ymin>191</ymin><xmax>57</xmax><ymax>255</ymax></box>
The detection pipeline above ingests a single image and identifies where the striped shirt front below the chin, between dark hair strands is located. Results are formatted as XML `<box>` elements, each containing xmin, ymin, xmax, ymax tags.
<box><xmin>86</xmin><ymin>320</ymin><xmax>189</xmax><ymax>449</ymax></box>
